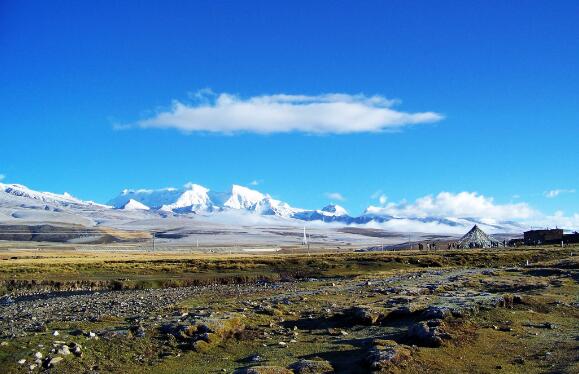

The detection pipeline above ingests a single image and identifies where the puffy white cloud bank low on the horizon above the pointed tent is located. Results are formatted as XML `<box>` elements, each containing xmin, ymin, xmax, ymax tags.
<box><xmin>367</xmin><ymin>192</ymin><xmax>537</xmax><ymax>220</ymax></box>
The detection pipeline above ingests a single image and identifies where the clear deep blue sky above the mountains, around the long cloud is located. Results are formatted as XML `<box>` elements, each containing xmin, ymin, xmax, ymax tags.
<box><xmin>0</xmin><ymin>1</ymin><xmax>579</xmax><ymax>219</ymax></box>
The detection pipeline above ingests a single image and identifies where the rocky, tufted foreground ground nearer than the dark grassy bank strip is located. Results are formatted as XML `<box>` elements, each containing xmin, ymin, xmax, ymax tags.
<box><xmin>0</xmin><ymin>250</ymin><xmax>579</xmax><ymax>373</ymax></box>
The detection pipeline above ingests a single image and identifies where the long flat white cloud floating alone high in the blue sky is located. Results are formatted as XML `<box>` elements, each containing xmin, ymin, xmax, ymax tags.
<box><xmin>137</xmin><ymin>90</ymin><xmax>443</xmax><ymax>134</ymax></box>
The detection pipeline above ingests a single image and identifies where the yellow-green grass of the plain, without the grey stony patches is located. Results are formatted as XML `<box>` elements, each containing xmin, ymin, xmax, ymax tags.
<box><xmin>0</xmin><ymin>247</ymin><xmax>579</xmax><ymax>373</ymax></box>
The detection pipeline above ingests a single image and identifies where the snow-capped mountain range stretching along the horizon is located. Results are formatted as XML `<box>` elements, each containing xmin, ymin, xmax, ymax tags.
<box><xmin>0</xmin><ymin>183</ymin><xmax>523</xmax><ymax>233</ymax></box>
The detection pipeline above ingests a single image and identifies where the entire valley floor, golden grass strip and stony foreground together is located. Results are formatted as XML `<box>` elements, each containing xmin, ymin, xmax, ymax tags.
<box><xmin>0</xmin><ymin>247</ymin><xmax>579</xmax><ymax>373</ymax></box>
